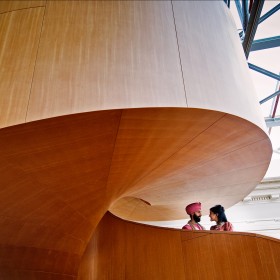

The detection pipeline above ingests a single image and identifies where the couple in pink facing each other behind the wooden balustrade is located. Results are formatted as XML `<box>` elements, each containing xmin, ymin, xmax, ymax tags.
<box><xmin>182</xmin><ymin>202</ymin><xmax>233</xmax><ymax>231</ymax></box>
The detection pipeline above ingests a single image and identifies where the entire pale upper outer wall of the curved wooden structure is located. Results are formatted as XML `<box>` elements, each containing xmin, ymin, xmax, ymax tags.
<box><xmin>0</xmin><ymin>1</ymin><xmax>264</xmax><ymax>128</ymax></box>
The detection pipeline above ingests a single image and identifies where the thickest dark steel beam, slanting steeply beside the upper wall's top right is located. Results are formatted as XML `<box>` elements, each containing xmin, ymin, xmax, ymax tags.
<box><xmin>243</xmin><ymin>0</ymin><xmax>264</xmax><ymax>58</ymax></box>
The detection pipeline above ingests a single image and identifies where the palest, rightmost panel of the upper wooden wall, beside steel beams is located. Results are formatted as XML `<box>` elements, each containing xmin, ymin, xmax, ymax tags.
<box><xmin>172</xmin><ymin>1</ymin><xmax>265</xmax><ymax>128</ymax></box>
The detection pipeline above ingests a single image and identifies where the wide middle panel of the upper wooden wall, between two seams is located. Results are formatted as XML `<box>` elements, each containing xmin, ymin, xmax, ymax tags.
<box><xmin>27</xmin><ymin>1</ymin><xmax>186</xmax><ymax>121</ymax></box>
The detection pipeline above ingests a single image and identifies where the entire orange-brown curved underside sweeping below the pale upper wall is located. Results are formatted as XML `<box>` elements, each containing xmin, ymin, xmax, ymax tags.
<box><xmin>0</xmin><ymin>108</ymin><xmax>271</xmax><ymax>279</ymax></box>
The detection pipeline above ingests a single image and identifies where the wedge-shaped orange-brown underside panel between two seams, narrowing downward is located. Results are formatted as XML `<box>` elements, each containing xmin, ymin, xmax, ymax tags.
<box><xmin>107</xmin><ymin>108</ymin><xmax>224</xmax><ymax>199</ymax></box>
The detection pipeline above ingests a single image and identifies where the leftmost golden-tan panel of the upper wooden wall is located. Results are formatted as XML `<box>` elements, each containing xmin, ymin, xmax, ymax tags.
<box><xmin>0</xmin><ymin>7</ymin><xmax>44</xmax><ymax>127</ymax></box>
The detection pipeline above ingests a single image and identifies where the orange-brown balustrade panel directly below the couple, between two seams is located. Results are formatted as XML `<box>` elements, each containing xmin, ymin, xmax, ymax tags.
<box><xmin>182</xmin><ymin>232</ymin><xmax>266</xmax><ymax>279</ymax></box>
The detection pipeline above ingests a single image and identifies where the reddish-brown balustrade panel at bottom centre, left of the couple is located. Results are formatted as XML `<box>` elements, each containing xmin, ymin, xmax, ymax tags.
<box><xmin>78</xmin><ymin>214</ymin><xmax>185</xmax><ymax>280</ymax></box>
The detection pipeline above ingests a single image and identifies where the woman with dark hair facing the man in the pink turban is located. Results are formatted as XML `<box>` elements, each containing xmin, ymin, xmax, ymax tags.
<box><xmin>209</xmin><ymin>205</ymin><xmax>233</xmax><ymax>231</ymax></box>
